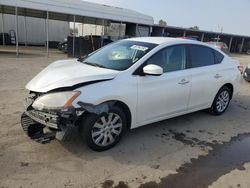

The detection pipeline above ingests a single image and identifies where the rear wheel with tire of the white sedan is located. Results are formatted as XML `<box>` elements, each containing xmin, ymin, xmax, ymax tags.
<box><xmin>209</xmin><ymin>86</ymin><xmax>232</xmax><ymax>116</ymax></box>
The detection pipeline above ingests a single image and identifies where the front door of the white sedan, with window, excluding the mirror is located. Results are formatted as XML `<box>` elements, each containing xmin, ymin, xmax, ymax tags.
<box><xmin>137</xmin><ymin>45</ymin><xmax>192</xmax><ymax>124</ymax></box>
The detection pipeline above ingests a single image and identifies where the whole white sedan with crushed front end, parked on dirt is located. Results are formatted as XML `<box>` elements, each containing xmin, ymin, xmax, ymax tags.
<box><xmin>22</xmin><ymin>37</ymin><xmax>241</xmax><ymax>151</ymax></box>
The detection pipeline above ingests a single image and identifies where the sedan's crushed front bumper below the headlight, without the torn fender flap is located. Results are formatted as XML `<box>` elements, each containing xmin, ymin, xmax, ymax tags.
<box><xmin>21</xmin><ymin>97</ymin><xmax>84</xmax><ymax>144</ymax></box>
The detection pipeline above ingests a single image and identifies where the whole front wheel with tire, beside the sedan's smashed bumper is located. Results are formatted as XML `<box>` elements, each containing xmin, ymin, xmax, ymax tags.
<box><xmin>80</xmin><ymin>106</ymin><xmax>126</xmax><ymax>152</ymax></box>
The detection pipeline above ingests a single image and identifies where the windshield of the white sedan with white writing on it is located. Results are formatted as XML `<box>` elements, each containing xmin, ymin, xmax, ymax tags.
<box><xmin>81</xmin><ymin>40</ymin><xmax>157</xmax><ymax>71</ymax></box>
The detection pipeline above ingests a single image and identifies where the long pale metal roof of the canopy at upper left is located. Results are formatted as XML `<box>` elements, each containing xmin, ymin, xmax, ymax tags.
<box><xmin>0</xmin><ymin>0</ymin><xmax>154</xmax><ymax>25</ymax></box>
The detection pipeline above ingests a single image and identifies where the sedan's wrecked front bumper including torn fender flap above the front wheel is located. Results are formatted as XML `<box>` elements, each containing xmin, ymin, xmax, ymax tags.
<box><xmin>21</xmin><ymin>93</ymin><xmax>114</xmax><ymax>144</ymax></box>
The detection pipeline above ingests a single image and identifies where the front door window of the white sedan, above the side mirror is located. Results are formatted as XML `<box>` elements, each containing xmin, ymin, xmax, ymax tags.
<box><xmin>147</xmin><ymin>45</ymin><xmax>186</xmax><ymax>72</ymax></box>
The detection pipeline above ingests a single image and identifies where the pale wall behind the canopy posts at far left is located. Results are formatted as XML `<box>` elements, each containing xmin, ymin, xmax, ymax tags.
<box><xmin>0</xmin><ymin>14</ymin><xmax>69</xmax><ymax>44</ymax></box>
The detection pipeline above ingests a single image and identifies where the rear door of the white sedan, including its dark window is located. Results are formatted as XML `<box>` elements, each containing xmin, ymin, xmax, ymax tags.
<box><xmin>188</xmin><ymin>45</ymin><xmax>223</xmax><ymax>110</ymax></box>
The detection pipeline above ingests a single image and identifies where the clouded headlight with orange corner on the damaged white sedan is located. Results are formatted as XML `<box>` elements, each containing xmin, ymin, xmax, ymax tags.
<box><xmin>32</xmin><ymin>91</ymin><xmax>81</xmax><ymax>110</ymax></box>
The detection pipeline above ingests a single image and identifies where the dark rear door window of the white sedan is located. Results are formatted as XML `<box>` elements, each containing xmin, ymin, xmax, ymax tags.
<box><xmin>190</xmin><ymin>45</ymin><xmax>215</xmax><ymax>68</ymax></box>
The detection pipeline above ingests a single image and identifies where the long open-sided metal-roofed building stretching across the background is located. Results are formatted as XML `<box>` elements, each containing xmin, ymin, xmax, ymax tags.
<box><xmin>0</xmin><ymin>0</ymin><xmax>250</xmax><ymax>56</ymax></box>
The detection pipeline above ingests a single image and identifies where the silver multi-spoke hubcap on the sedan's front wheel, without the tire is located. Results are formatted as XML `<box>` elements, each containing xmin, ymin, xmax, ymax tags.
<box><xmin>91</xmin><ymin>113</ymin><xmax>122</xmax><ymax>147</ymax></box>
